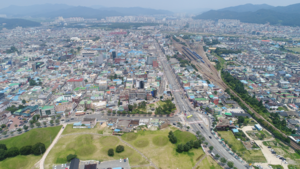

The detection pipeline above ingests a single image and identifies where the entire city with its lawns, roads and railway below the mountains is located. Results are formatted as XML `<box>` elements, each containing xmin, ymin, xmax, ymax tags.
<box><xmin>0</xmin><ymin>1</ymin><xmax>300</xmax><ymax>169</ymax></box>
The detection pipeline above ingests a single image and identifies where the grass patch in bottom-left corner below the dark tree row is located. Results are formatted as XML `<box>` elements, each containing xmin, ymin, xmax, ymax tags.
<box><xmin>0</xmin><ymin>155</ymin><xmax>42</xmax><ymax>169</ymax></box>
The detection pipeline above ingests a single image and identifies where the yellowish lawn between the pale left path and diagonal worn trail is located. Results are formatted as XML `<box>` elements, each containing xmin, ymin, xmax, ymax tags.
<box><xmin>45</xmin><ymin>134</ymin><xmax>148</xmax><ymax>168</ymax></box>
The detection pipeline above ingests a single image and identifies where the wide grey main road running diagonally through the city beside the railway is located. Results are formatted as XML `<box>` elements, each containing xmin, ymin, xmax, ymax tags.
<box><xmin>156</xmin><ymin>40</ymin><xmax>247</xmax><ymax>169</ymax></box>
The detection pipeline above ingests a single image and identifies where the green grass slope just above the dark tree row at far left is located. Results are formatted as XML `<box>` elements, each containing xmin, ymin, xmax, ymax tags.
<box><xmin>0</xmin><ymin>126</ymin><xmax>61</xmax><ymax>148</ymax></box>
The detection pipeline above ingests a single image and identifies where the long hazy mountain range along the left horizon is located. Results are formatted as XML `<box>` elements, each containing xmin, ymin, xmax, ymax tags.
<box><xmin>0</xmin><ymin>4</ymin><xmax>172</xmax><ymax>19</ymax></box>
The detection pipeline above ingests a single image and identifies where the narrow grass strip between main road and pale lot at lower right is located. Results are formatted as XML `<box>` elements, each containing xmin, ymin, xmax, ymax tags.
<box><xmin>218</xmin><ymin>131</ymin><xmax>266</xmax><ymax>163</ymax></box>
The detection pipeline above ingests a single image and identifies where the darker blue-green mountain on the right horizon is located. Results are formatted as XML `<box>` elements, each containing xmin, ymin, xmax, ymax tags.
<box><xmin>194</xmin><ymin>3</ymin><xmax>300</xmax><ymax>26</ymax></box>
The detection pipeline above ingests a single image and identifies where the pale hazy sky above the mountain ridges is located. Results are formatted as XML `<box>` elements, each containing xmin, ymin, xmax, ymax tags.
<box><xmin>0</xmin><ymin>0</ymin><xmax>300</xmax><ymax>10</ymax></box>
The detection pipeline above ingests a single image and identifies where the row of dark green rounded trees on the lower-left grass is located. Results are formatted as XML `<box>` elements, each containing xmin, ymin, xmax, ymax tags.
<box><xmin>0</xmin><ymin>143</ymin><xmax>46</xmax><ymax>161</ymax></box>
